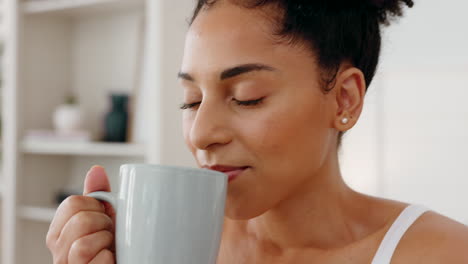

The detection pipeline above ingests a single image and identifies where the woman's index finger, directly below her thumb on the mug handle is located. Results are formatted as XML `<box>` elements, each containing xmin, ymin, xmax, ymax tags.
<box><xmin>46</xmin><ymin>195</ymin><xmax>105</xmax><ymax>249</ymax></box>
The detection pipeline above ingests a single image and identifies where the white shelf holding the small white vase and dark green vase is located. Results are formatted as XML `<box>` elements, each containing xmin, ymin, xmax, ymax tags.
<box><xmin>21</xmin><ymin>141</ymin><xmax>146</xmax><ymax>157</ymax></box>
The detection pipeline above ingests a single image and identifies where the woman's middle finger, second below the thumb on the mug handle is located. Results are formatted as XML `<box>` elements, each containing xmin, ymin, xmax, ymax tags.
<box><xmin>56</xmin><ymin>211</ymin><xmax>113</xmax><ymax>256</ymax></box>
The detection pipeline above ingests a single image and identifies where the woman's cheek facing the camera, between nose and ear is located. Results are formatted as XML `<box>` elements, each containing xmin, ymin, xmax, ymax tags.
<box><xmin>245</xmin><ymin>100</ymin><xmax>328</xmax><ymax>168</ymax></box>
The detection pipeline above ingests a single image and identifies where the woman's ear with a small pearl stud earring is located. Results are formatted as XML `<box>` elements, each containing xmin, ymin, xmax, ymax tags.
<box><xmin>334</xmin><ymin>67</ymin><xmax>366</xmax><ymax>131</ymax></box>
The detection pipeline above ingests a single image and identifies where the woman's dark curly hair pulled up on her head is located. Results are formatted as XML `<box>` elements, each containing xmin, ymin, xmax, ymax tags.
<box><xmin>190</xmin><ymin>0</ymin><xmax>414</xmax><ymax>148</ymax></box>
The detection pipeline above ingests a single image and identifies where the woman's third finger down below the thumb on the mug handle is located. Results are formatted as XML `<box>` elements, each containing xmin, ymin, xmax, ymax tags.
<box><xmin>68</xmin><ymin>230</ymin><xmax>114</xmax><ymax>264</ymax></box>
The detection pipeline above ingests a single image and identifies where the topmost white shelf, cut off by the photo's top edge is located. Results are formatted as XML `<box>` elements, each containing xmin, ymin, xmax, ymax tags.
<box><xmin>21</xmin><ymin>0</ymin><xmax>144</xmax><ymax>17</ymax></box>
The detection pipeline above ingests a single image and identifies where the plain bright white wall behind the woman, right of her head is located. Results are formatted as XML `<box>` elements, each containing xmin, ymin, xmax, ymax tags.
<box><xmin>342</xmin><ymin>0</ymin><xmax>468</xmax><ymax>223</ymax></box>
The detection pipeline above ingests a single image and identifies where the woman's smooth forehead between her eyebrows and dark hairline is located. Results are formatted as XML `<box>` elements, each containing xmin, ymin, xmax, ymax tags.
<box><xmin>182</xmin><ymin>1</ymin><xmax>282</xmax><ymax>71</ymax></box>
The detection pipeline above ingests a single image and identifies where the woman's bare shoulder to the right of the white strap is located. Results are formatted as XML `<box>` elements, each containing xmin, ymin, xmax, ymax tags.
<box><xmin>392</xmin><ymin>211</ymin><xmax>468</xmax><ymax>264</ymax></box>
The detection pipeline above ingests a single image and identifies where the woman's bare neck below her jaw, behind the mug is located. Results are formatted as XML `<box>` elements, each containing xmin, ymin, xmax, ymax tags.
<box><xmin>228</xmin><ymin>150</ymin><xmax>369</xmax><ymax>252</ymax></box>
